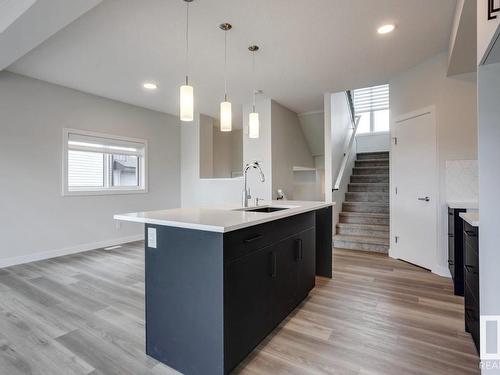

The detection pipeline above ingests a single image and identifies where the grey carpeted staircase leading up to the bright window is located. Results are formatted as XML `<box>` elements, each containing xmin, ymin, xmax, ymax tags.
<box><xmin>333</xmin><ymin>152</ymin><xmax>389</xmax><ymax>253</ymax></box>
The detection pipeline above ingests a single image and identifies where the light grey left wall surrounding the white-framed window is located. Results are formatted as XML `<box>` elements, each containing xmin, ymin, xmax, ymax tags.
<box><xmin>0</xmin><ymin>72</ymin><xmax>180</xmax><ymax>267</ymax></box>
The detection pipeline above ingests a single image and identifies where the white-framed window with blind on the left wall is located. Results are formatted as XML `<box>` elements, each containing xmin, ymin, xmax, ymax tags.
<box><xmin>63</xmin><ymin>129</ymin><xmax>147</xmax><ymax>195</ymax></box>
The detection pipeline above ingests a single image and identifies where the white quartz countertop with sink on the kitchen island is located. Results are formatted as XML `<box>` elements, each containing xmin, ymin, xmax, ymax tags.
<box><xmin>114</xmin><ymin>201</ymin><xmax>335</xmax><ymax>233</ymax></box>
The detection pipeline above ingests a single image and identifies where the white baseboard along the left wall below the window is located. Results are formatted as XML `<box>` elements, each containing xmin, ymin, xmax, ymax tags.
<box><xmin>0</xmin><ymin>234</ymin><xmax>144</xmax><ymax>268</ymax></box>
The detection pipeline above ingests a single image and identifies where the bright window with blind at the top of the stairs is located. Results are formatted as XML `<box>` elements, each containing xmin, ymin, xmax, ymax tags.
<box><xmin>353</xmin><ymin>85</ymin><xmax>389</xmax><ymax>134</ymax></box>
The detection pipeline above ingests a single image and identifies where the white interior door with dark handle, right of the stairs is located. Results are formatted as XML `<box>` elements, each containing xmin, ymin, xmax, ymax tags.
<box><xmin>391</xmin><ymin>107</ymin><xmax>438</xmax><ymax>269</ymax></box>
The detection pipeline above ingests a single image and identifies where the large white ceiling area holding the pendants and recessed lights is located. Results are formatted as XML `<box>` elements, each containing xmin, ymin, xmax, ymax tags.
<box><xmin>4</xmin><ymin>0</ymin><xmax>456</xmax><ymax>123</ymax></box>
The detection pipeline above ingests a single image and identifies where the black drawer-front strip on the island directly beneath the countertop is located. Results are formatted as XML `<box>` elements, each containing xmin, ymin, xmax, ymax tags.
<box><xmin>224</xmin><ymin>212</ymin><xmax>315</xmax><ymax>260</ymax></box>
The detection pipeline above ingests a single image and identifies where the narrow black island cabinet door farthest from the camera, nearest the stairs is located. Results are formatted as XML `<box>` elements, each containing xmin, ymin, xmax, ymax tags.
<box><xmin>297</xmin><ymin>228</ymin><xmax>316</xmax><ymax>303</ymax></box>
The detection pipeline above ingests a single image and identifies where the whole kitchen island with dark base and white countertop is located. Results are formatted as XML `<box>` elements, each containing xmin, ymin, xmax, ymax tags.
<box><xmin>115</xmin><ymin>201</ymin><xmax>332</xmax><ymax>375</ymax></box>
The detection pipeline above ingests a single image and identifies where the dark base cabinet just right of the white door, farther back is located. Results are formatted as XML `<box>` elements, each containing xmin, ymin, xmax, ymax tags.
<box><xmin>448</xmin><ymin>208</ymin><xmax>467</xmax><ymax>296</ymax></box>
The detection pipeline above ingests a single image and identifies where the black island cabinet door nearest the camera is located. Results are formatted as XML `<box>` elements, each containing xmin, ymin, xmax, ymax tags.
<box><xmin>224</xmin><ymin>246</ymin><xmax>276</xmax><ymax>373</ymax></box>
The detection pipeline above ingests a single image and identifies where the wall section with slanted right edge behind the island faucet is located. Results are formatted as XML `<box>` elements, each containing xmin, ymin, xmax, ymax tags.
<box><xmin>271</xmin><ymin>100</ymin><xmax>314</xmax><ymax>199</ymax></box>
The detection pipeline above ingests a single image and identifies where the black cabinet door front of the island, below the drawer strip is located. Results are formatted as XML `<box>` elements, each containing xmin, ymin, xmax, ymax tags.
<box><xmin>225</xmin><ymin>228</ymin><xmax>315</xmax><ymax>373</ymax></box>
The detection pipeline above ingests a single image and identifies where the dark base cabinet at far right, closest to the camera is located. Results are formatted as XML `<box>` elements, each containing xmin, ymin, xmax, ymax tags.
<box><xmin>463</xmin><ymin>221</ymin><xmax>480</xmax><ymax>353</ymax></box>
